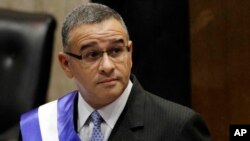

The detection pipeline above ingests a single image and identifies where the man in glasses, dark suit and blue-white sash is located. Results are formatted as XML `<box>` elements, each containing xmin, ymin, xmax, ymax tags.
<box><xmin>20</xmin><ymin>3</ymin><xmax>210</xmax><ymax>141</ymax></box>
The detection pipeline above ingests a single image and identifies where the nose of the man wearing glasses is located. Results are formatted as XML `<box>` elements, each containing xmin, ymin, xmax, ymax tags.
<box><xmin>98</xmin><ymin>52</ymin><xmax>115</xmax><ymax>75</ymax></box>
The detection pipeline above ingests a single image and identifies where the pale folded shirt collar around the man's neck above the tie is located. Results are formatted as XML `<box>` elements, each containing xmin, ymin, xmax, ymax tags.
<box><xmin>77</xmin><ymin>81</ymin><xmax>133</xmax><ymax>131</ymax></box>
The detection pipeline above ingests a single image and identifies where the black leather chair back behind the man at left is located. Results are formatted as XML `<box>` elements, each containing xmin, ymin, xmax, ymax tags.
<box><xmin>0</xmin><ymin>9</ymin><xmax>56</xmax><ymax>139</ymax></box>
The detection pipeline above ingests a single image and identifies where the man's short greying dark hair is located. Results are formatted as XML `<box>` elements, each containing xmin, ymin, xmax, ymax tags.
<box><xmin>61</xmin><ymin>3</ymin><xmax>129</xmax><ymax>47</ymax></box>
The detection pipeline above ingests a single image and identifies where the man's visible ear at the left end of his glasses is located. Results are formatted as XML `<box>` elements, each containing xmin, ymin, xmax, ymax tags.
<box><xmin>58</xmin><ymin>52</ymin><xmax>73</xmax><ymax>78</ymax></box>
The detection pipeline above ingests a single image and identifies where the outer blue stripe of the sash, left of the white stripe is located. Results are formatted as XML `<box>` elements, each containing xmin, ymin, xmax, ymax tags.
<box><xmin>20</xmin><ymin>109</ymin><xmax>42</xmax><ymax>141</ymax></box>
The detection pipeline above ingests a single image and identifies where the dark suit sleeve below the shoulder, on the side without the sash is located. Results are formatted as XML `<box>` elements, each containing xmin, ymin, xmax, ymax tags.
<box><xmin>178</xmin><ymin>114</ymin><xmax>211</xmax><ymax>141</ymax></box>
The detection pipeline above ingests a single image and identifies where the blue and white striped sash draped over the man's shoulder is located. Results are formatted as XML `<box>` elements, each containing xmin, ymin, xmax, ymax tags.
<box><xmin>20</xmin><ymin>91</ymin><xmax>80</xmax><ymax>141</ymax></box>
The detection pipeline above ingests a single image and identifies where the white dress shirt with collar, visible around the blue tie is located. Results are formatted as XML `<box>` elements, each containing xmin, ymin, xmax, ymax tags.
<box><xmin>77</xmin><ymin>81</ymin><xmax>133</xmax><ymax>141</ymax></box>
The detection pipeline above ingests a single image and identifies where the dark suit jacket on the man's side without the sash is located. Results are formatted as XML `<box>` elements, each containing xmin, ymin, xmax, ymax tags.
<box><xmin>109</xmin><ymin>77</ymin><xmax>210</xmax><ymax>141</ymax></box>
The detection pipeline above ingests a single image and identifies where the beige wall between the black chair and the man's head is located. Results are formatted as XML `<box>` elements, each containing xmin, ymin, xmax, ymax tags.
<box><xmin>0</xmin><ymin>0</ymin><xmax>89</xmax><ymax>101</ymax></box>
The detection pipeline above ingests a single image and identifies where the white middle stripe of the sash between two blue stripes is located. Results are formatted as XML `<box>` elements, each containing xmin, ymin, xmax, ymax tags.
<box><xmin>38</xmin><ymin>101</ymin><xmax>59</xmax><ymax>141</ymax></box>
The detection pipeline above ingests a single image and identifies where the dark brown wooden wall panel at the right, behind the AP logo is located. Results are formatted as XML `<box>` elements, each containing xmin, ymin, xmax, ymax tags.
<box><xmin>190</xmin><ymin>0</ymin><xmax>250</xmax><ymax>141</ymax></box>
